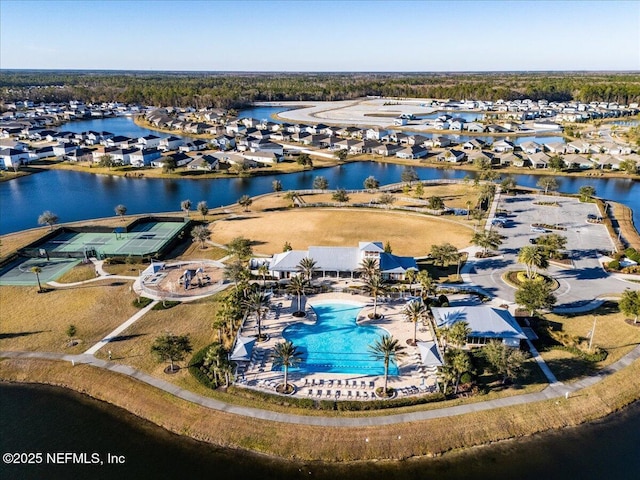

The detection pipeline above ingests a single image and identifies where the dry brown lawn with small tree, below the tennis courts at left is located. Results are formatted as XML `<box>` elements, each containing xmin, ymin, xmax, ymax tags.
<box><xmin>0</xmin><ymin>281</ymin><xmax>137</xmax><ymax>353</ymax></box>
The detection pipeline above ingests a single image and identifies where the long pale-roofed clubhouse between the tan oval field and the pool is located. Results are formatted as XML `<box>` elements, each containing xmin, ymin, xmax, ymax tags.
<box><xmin>269</xmin><ymin>242</ymin><xmax>418</xmax><ymax>280</ymax></box>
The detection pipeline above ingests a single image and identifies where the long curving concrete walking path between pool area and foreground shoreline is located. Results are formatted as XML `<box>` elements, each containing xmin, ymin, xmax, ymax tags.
<box><xmin>0</xmin><ymin>346</ymin><xmax>640</xmax><ymax>427</ymax></box>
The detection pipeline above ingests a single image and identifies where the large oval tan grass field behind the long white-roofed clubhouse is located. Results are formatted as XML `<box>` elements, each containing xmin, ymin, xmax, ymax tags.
<box><xmin>211</xmin><ymin>208</ymin><xmax>473</xmax><ymax>256</ymax></box>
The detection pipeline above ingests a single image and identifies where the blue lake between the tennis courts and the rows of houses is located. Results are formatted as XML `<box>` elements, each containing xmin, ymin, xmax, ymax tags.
<box><xmin>0</xmin><ymin>162</ymin><xmax>640</xmax><ymax>234</ymax></box>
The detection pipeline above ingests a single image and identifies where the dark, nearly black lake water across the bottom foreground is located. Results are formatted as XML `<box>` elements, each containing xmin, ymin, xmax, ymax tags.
<box><xmin>0</xmin><ymin>384</ymin><xmax>640</xmax><ymax>480</ymax></box>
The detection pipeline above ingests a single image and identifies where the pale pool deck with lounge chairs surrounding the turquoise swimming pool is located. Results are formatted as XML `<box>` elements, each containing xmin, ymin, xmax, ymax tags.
<box><xmin>238</xmin><ymin>293</ymin><xmax>437</xmax><ymax>400</ymax></box>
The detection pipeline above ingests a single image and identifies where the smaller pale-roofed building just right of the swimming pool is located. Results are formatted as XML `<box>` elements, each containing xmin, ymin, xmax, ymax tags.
<box><xmin>431</xmin><ymin>305</ymin><xmax>527</xmax><ymax>348</ymax></box>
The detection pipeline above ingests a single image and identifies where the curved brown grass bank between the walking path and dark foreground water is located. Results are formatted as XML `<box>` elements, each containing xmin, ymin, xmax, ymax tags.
<box><xmin>0</xmin><ymin>359</ymin><xmax>640</xmax><ymax>462</ymax></box>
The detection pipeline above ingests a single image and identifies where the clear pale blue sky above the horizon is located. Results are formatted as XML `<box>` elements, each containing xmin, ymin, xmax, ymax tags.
<box><xmin>0</xmin><ymin>0</ymin><xmax>640</xmax><ymax>72</ymax></box>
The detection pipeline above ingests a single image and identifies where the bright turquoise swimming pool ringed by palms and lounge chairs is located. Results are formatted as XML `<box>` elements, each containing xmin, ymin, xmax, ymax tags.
<box><xmin>282</xmin><ymin>302</ymin><xmax>398</xmax><ymax>375</ymax></box>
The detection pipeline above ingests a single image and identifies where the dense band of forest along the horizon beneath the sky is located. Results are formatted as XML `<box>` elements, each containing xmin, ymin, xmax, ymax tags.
<box><xmin>0</xmin><ymin>70</ymin><xmax>640</xmax><ymax>108</ymax></box>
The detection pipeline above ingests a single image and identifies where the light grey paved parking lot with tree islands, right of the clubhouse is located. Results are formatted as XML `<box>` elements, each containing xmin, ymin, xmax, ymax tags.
<box><xmin>470</xmin><ymin>195</ymin><xmax>629</xmax><ymax>308</ymax></box>
